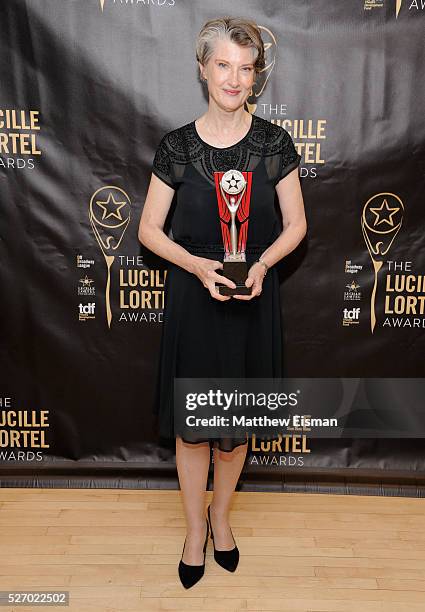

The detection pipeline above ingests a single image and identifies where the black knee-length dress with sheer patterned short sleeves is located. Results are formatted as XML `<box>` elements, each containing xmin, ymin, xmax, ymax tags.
<box><xmin>152</xmin><ymin>115</ymin><xmax>301</xmax><ymax>451</ymax></box>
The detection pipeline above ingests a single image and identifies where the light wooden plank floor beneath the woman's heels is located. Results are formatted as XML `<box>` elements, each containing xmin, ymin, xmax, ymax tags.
<box><xmin>0</xmin><ymin>488</ymin><xmax>425</xmax><ymax>612</ymax></box>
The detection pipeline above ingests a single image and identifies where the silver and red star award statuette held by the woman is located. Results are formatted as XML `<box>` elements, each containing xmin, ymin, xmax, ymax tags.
<box><xmin>214</xmin><ymin>170</ymin><xmax>252</xmax><ymax>295</ymax></box>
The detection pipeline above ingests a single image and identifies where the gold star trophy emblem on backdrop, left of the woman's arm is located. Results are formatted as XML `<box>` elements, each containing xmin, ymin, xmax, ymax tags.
<box><xmin>89</xmin><ymin>185</ymin><xmax>131</xmax><ymax>327</ymax></box>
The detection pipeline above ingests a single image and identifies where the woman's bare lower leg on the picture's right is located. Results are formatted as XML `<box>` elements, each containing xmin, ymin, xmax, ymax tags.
<box><xmin>210</xmin><ymin>442</ymin><xmax>248</xmax><ymax>550</ymax></box>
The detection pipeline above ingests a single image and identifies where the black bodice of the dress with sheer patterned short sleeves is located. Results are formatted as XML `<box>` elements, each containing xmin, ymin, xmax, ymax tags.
<box><xmin>152</xmin><ymin>115</ymin><xmax>301</xmax><ymax>244</ymax></box>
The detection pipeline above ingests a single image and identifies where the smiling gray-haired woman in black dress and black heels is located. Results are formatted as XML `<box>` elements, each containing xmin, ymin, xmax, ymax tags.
<box><xmin>139</xmin><ymin>17</ymin><xmax>306</xmax><ymax>588</ymax></box>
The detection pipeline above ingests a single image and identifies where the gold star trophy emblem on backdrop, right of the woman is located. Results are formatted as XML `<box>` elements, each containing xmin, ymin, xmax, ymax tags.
<box><xmin>361</xmin><ymin>193</ymin><xmax>404</xmax><ymax>333</ymax></box>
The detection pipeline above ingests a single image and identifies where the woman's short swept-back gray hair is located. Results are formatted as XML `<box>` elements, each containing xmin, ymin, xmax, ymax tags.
<box><xmin>196</xmin><ymin>17</ymin><xmax>266</xmax><ymax>74</ymax></box>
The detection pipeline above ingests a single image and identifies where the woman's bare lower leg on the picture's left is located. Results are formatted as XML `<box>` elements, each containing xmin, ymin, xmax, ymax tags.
<box><xmin>176</xmin><ymin>436</ymin><xmax>211</xmax><ymax>565</ymax></box>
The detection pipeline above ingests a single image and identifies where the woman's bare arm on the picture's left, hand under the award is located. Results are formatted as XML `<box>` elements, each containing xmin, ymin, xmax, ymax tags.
<box><xmin>138</xmin><ymin>174</ymin><xmax>236</xmax><ymax>301</ymax></box>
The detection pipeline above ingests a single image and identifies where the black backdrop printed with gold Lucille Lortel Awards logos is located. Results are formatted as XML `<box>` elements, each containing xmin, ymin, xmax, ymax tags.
<box><xmin>0</xmin><ymin>0</ymin><xmax>425</xmax><ymax>486</ymax></box>
